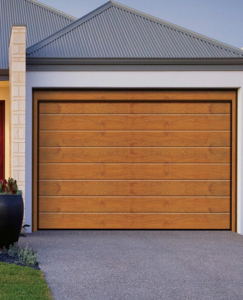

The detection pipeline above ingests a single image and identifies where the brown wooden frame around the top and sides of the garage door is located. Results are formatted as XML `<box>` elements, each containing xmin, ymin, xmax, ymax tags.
<box><xmin>32</xmin><ymin>89</ymin><xmax>237</xmax><ymax>232</ymax></box>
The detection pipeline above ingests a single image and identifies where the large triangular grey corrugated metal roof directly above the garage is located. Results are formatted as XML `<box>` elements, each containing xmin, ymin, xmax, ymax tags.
<box><xmin>27</xmin><ymin>1</ymin><xmax>243</xmax><ymax>58</ymax></box>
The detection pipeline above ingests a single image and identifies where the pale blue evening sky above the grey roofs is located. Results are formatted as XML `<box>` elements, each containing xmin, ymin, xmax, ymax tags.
<box><xmin>38</xmin><ymin>0</ymin><xmax>243</xmax><ymax>48</ymax></box>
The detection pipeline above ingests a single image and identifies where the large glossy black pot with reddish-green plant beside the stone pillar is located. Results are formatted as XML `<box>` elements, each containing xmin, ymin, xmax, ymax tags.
<box><xmin>0</xmin><ymin>178</ymin><xmax>24</xmax><ymax>248</ymax></box>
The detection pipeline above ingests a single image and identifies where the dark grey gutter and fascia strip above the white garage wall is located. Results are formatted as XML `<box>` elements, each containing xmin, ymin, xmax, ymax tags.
<box><xmin>26</xmin><ymin>58</ymin><xmax>243</xmax><ymax>71</ymax></box>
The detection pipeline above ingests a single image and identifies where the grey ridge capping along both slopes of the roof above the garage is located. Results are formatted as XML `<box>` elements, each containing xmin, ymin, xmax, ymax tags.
<box><xmin>27</xmin><ymin>0</ymin><xmax>243</xmax><ymax>56</ymax></box>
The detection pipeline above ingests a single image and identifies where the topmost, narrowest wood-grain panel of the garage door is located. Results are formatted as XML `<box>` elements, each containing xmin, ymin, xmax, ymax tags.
<box><xmin>39</xmin><ymin>101</ymin><xmax>231</xmax><ymax>114</ymax></box>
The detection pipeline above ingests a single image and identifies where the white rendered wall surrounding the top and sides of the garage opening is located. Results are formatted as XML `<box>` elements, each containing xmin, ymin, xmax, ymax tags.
<box><xmin>25</xmin><ymin>71</ymin><xmax>243</xmax><ymax>234</ymax></box>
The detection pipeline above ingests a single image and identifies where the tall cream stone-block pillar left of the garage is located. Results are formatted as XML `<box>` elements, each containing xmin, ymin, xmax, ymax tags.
<box><xmin>9</xmin><ymin>26</ymin><xmax>26</xmax><ymax>203</ymax></box>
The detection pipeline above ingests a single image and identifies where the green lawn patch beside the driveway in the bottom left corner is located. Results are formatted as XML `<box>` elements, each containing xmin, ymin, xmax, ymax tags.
<box><xmin>0</xmin><ymin>262</ymin><xmax>52</xmax><ymax>300</ymax></box>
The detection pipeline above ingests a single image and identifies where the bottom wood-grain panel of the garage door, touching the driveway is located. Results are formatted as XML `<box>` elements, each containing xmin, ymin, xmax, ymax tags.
<box><xmin>39</xmin><ymin>213</ymin><xmax>230</xmax><ymax>229</ymax></box>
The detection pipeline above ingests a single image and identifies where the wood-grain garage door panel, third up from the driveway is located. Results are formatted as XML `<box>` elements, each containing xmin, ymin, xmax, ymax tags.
<box><xmin>39</xmin><ymin>180</ymin><xmax>230</xmax><ymax>196</ymax></box>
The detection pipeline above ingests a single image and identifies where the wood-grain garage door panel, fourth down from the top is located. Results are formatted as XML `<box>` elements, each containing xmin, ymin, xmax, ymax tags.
<box><xmin>39</xmin><ymin>147</ymin><xmax>230</xmax><ymax>163</ymax></box>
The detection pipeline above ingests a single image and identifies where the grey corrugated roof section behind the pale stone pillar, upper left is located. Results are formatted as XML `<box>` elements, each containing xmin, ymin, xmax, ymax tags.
<box><xmin>0</xmin><ymin>0</ymin><xmax>76</xmax><ymax>69</ymax></box>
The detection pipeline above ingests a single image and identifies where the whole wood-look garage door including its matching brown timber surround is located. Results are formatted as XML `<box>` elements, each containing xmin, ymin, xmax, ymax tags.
<box><xmin>34</xmin><ymin>91</ymin><xmax>235</xmax><ymax>230</ymax></box>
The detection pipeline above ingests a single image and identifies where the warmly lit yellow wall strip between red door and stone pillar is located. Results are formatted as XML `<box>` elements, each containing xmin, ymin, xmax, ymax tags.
<box><xmin>0</xmin><ymin>81</ymin><xmax>10</xmax><ymax>178</ymax></box>
